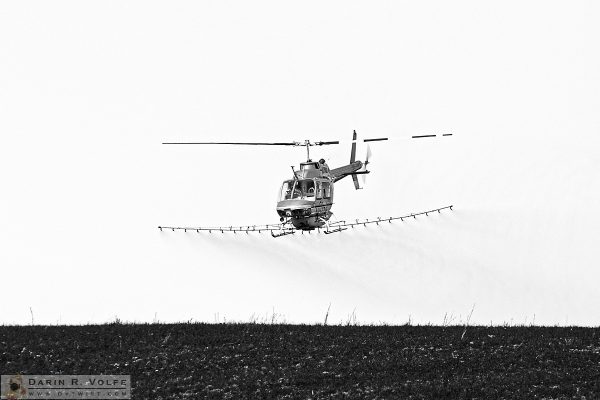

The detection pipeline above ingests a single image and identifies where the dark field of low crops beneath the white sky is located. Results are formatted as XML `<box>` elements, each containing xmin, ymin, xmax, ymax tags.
<box><xmin>0</xmin><ymin>324</ymin><xmax>600</xmax><ymax>399</ymax></box>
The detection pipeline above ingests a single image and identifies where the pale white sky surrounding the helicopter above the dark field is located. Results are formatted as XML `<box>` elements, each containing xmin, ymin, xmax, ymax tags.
<box><xmin>0</xmin><ymin>1</ymin><xmax>600</xmax><ymax>325</ymax></box>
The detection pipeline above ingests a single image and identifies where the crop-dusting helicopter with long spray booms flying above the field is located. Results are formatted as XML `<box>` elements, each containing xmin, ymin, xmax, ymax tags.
<box><xmin>158</xmin><ymin>131</ymin><xmax>452</xmax><ymax>237</ymax></box>
